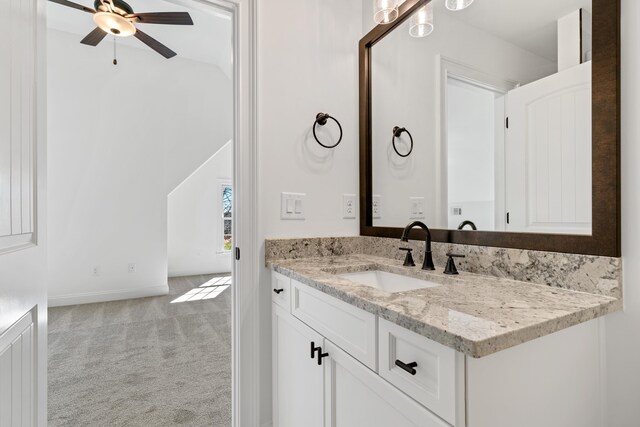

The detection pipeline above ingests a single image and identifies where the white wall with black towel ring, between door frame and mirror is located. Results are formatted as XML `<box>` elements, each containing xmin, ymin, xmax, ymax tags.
<box><xmin>257</xmin><ymin>0</ymin><xmax>362</xmax><ymax>423</ymax></box>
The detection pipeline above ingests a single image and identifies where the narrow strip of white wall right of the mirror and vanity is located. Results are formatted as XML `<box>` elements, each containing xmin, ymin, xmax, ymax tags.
<box><xmin>595</xmin><ymin>0</ymin><xmax>640</xmax><ymax>427</ymax></box>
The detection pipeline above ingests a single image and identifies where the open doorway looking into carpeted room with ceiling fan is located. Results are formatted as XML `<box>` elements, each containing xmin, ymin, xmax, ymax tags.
<box><xmin>48</xmin><ymin>0</ymin><xmax>240</xmax><ymax>425</ymax></box>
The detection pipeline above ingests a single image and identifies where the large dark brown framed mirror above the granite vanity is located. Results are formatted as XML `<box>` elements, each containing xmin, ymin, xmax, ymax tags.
<box><xmin>360</xmin><ymin>0</ymin><xmax>619</xmax><ymax>254</ymax></box>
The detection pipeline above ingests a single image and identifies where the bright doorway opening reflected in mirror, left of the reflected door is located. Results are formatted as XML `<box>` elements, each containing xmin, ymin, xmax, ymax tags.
<box><xmin>443</xmin><ymin>75</ymin><xmax>505</xmax><ymax>231</ymax></box>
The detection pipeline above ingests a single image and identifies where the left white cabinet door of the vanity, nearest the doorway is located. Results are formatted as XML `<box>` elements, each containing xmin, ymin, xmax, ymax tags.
<box><xmin>272</xmin><ymin>304</ymin><xmax>326</xmax><ymax>427</ymax></box>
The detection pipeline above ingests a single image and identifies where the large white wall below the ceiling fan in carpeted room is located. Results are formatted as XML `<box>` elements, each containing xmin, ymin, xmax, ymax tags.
<box><xmin>48</xmin><ymin>30</ymin><xmax>232</xmax><ymax>304</ymax></box>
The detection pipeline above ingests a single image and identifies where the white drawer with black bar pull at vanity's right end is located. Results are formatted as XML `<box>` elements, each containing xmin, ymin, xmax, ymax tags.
<box><xmin>378</xmin><ymin>319</ymin><xmax>464</xmax><ymax>426</ymax></box>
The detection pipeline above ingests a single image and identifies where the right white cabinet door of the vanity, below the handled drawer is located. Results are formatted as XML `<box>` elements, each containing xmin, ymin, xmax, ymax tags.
<box><xmin>323</xmin><ymin>340</ymin><xmax>449</xmax><ymax>427</ymax></box>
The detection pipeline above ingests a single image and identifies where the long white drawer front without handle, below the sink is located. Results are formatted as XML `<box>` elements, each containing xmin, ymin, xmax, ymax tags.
<box><xmin>291</xmin><ymin>280</ymin><xmax>377</xmax><ymax>371</ymax></box>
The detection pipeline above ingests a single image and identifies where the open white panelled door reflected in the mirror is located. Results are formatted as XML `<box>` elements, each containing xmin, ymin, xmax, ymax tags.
<box><xmin>506</xmin><ymin>62</ymin><xmax>591</xmax><ymax>234</ymax></box>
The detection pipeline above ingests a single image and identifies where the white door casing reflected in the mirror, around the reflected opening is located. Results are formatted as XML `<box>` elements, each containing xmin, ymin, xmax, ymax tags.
<box><xmin>435</xmin><ymin>55</ymin><xmax>520</xmax><ymax>228</ymax></box>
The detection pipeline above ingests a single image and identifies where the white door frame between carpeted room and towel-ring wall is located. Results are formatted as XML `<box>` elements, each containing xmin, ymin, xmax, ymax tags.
<box><xmin>190</xmin><ymin>0</ymin><xmax>261</xmax><ymax>427</ymax></box>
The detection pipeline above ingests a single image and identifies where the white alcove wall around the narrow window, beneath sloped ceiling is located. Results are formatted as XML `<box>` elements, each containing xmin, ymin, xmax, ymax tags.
<box><xmin>168</xmin><ymin>141</ymin><xmax>233</xmax><ymax>277</ymax></box>
